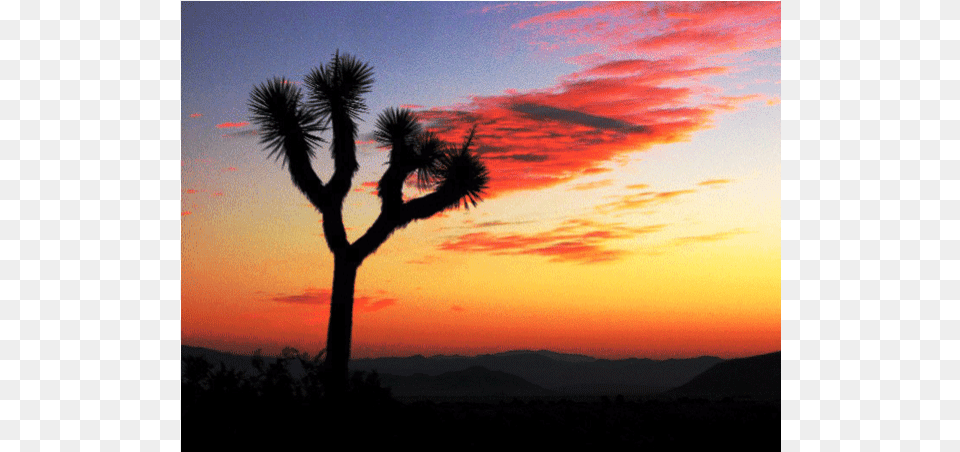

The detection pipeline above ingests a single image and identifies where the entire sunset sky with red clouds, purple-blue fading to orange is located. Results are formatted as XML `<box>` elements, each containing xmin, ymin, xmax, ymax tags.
<box><xmin>181</xmin><ymin>2</ymin><xmax>780</xmax><ymax>359</ymax></box>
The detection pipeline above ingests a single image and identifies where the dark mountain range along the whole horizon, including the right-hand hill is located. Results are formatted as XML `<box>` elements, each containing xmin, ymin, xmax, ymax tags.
<box><xmin>181</xmin><ymin>345</ymin><xmax>780</xmax><ymax>399</ymax></box>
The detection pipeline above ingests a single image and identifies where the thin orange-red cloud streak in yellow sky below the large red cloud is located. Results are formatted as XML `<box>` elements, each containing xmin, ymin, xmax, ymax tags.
<box><xmin>439</xmin><ymin>220</ymin><xmax>666</xmax><ymax>264</ymax></box>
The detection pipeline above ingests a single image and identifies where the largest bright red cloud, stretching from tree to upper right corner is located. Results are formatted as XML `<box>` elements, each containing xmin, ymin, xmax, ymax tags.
<box><xmin>419</xmin><ymin>2</ymin><xmax>780</xmax><ymax>196</ymax></box>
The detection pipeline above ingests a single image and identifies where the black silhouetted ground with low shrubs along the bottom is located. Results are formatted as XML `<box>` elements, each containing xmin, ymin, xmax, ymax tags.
<box><xmin>182</xmin><ymin>352</ymin><xmax>780</xmax><ymax>451</ymax></box>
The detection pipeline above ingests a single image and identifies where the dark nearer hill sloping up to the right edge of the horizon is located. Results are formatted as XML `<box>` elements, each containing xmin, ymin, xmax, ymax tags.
<box><xmin>665</xmin><ymin>352</ymin><xmax>780</xmax><ymax>400</ymax></box>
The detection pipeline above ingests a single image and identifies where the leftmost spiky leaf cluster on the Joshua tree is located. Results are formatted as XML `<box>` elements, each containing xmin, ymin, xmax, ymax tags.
<box><xmin>249</xmin><ymin>77</ymin><xmax>324</xmax><ymax>164</ymax></box>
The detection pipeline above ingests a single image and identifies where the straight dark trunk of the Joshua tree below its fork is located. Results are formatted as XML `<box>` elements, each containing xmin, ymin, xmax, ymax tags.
<box><xmin>325</xmin><ymin>257</ymin><xmax>359</xmax><ymax>398</ymax></box>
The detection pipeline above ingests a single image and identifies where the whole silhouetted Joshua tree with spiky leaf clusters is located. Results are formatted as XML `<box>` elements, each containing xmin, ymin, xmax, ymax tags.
<box><xmin>250</xmin><ymin>52</ymin><xmax>489</xmax><ymax>394</ymax></box>
